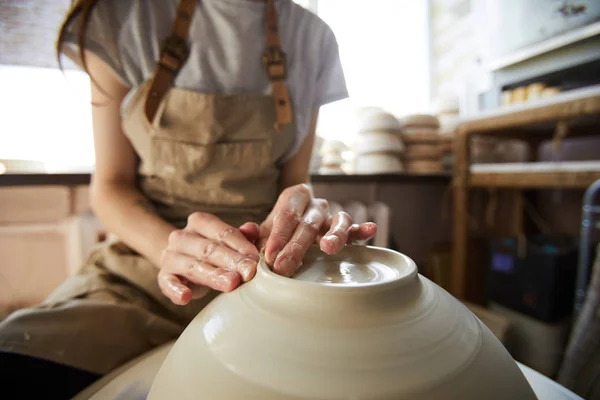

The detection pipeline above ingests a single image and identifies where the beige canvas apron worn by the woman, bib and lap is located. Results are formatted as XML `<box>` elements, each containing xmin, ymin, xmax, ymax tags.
<box><xmin>0</xmin><ymin>0</ymin><xmax>295</xmax><ymax>374</ymax></box>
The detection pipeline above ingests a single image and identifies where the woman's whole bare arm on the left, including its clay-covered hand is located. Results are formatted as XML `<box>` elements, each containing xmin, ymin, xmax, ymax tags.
<box><xmin>78</xmin><ymin>54</ymin><xmax>259</xmax><ymax>304</ymax></box>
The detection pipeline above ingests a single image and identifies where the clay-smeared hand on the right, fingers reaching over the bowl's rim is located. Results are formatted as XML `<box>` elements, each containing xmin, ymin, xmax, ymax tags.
<box><xmin>257</xmin><ymin>184</ymin><xmax>377</xmax><ymax>276</ymax></box>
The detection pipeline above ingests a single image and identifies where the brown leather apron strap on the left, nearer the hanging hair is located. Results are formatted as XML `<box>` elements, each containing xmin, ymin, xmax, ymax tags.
<box><xmin>144</xmin><ymin>0</ymin><xmax>196</xmax><ymax>122</ymax></box>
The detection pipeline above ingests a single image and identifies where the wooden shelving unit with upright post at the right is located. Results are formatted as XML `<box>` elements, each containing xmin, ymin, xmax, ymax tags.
<box><xmin>450</xmin><ymin>86</ymin><xmax>600</xmax><ymax>301</ymax></box>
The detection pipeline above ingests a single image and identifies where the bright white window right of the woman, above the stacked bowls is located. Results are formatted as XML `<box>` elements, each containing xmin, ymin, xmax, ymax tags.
<box><xmin>317</xmin><ymin>0</ymin><xmax>429</xmax><ymax>142</ymax></box>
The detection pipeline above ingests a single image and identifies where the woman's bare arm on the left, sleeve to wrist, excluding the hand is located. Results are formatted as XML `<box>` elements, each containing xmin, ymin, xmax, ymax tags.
<box><xmin>86</xmin><ymin>53</ymin><xmax>175</xmax><ymax>265</ymax></box>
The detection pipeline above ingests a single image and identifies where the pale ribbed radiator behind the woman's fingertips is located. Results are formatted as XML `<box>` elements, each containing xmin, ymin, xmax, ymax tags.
<box><xmin>329</xmin><ymin>201</ymin><xmax>391</xmax><ymax>248</ymax></box>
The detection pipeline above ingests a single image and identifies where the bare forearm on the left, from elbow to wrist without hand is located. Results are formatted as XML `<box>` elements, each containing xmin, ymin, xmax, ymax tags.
<box><xmin>92</xmin><ymin>183</ymin><xmax>175</xmax><ymax>265</ymax></box>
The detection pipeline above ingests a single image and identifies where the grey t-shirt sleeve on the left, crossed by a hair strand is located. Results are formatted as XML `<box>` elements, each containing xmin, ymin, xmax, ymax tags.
<box><xmin>63</xmin><ymin>0</ymin><xmax>131</xmax><ymax>86</ymax></box>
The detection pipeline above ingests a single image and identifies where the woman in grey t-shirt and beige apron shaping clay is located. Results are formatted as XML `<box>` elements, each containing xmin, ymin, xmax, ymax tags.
<box><xmin>0</xmin><ymin>0</ymin><xmax>376</xmax><ymax>398</ymax></box>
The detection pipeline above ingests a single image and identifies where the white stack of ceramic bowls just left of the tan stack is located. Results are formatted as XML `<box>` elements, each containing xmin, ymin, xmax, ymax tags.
<box><xmin>353</xmin><ymin>108</ymin><xmax>404</xmax><ymax>174</ymax></box>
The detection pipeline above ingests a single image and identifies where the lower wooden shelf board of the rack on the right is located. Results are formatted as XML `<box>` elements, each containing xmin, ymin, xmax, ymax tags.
<box><xmin>468</xmin><ymin>171</ymin><xmax>600</xmax><ymax>189</ymax></box>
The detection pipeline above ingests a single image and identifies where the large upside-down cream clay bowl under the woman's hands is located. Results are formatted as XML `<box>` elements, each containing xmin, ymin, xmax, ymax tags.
<box><xmin>148</xmin><ymin>246</ymin><xmax>536</xmax><ymax>400</ymax></box>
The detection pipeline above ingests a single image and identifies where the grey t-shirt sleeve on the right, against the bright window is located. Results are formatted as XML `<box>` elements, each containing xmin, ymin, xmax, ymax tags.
<box><xmin>316</xmin><ymin>27</ymin><xmax>348</xmax><ymax>108</ymax></box>
